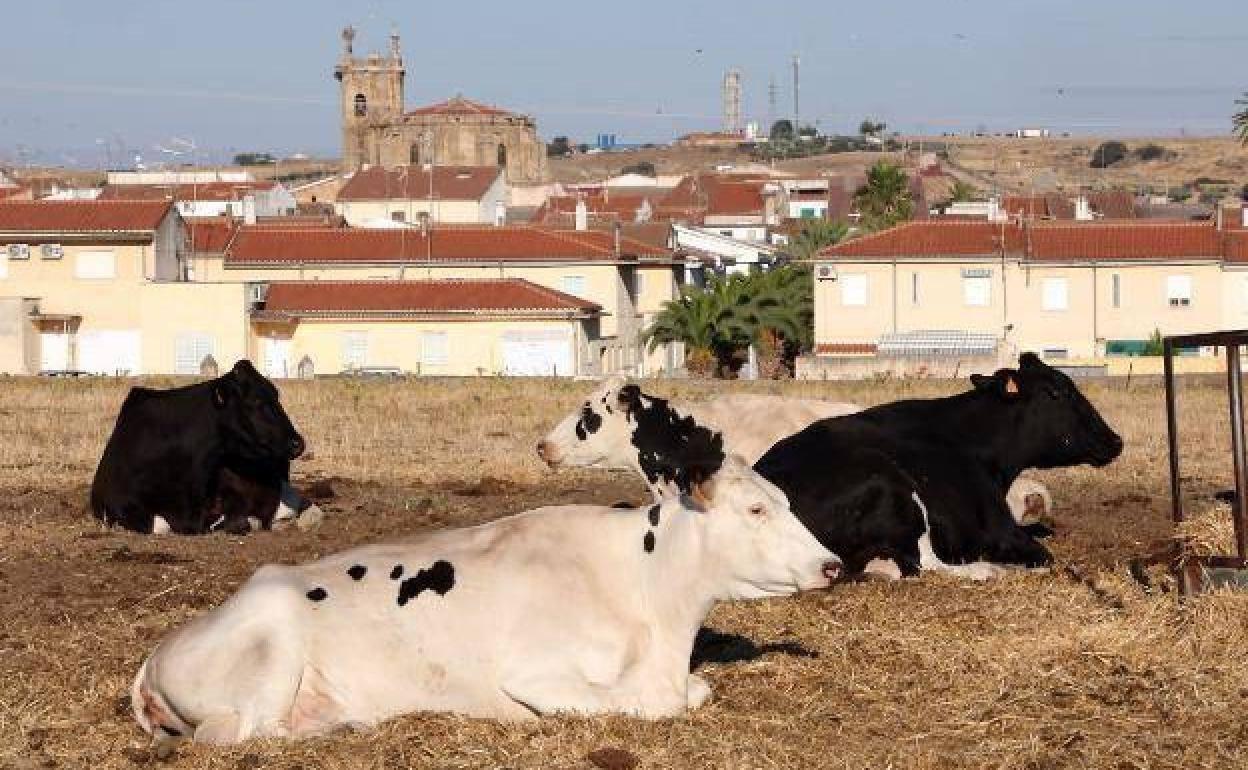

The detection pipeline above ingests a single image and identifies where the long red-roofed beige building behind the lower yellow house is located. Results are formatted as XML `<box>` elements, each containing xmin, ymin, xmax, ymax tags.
<box><xmin>205</xmin><ymin>226</ymin><xmax>683</xmax><ymax>374</ymax></box>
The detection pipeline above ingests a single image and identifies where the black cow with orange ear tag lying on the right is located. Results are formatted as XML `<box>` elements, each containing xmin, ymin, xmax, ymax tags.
<box><xmin>755</xmin><ymin>353</ymin><xmax>1122</xmax><ymax>578</ymax></box>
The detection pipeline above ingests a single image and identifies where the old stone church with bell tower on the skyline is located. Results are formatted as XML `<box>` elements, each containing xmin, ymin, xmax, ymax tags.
<box><xmin>333</xmin><ymin>26</ymin><xmax>545</xmax><ymax>185</ymax></box>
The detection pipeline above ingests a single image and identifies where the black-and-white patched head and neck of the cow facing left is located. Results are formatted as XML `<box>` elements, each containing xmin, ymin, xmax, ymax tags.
<box><xmin>537</xmin><ymin>377</ymin><xmax>724</xmax><ymax>492</ymax></box>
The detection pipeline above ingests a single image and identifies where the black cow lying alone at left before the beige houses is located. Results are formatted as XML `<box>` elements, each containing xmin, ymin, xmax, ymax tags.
<box><xmin>91</xmin><ymin>361</ymin><xmax>305</xmax><ymax>534</ymax></box>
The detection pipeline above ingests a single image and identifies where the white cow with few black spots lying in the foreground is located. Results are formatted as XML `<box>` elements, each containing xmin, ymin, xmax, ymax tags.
<box><xmin>131</xmin><ymin>453</ymin><xmax>840</xmax><ymax>744</ymax></box>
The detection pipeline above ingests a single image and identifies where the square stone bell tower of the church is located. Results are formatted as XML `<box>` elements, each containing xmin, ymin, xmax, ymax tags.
<box><xmin>333</xmin><ymin>26</ymin><xmax>406</xmax><ymax>171</ymax></box>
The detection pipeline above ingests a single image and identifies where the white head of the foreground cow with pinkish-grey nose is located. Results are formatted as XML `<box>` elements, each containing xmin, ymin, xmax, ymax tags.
<box><xmin>681</xmin><ymin>454</ymin><xmax>841</xmax><ymax>599</ymax></box>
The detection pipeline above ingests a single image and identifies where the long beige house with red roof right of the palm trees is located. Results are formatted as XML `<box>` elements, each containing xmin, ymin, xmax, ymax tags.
<box><xmin>815</xmin><ymin>221</ymin><xmax>1248</xmax><ymax>374</ymax></box>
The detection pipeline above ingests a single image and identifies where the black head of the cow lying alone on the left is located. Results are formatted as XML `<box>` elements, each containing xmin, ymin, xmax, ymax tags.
<box><xmin>210</xmin><ymin>359</ymin><xmax>305</xmax><ymax>462</ymax></box>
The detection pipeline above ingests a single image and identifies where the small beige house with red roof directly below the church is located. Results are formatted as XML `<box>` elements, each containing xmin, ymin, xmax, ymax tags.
<box><xmin>334</xmin><ymin>166</ymin><xmax>507</xmax><ymax>227</ymax></box>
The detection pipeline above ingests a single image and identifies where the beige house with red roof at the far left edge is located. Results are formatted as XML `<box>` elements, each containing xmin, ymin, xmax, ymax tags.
<box><xmin>0</xmin><ymin>201</ymin><xmax>248</xmax><ymax>374</ymax></box>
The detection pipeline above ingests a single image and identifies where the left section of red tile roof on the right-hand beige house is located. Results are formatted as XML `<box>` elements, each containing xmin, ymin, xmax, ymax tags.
<box><xmin>820</xmin><ymin>220</ymin><xmax>1022</xmax><ymax>260</ymax></box>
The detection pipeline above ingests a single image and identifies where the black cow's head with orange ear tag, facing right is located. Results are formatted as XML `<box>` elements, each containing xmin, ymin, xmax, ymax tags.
<box><xmin>971</xmin><ymin>353</ymin><xmax>1122</xmax><ymax>468</ymax></box>
